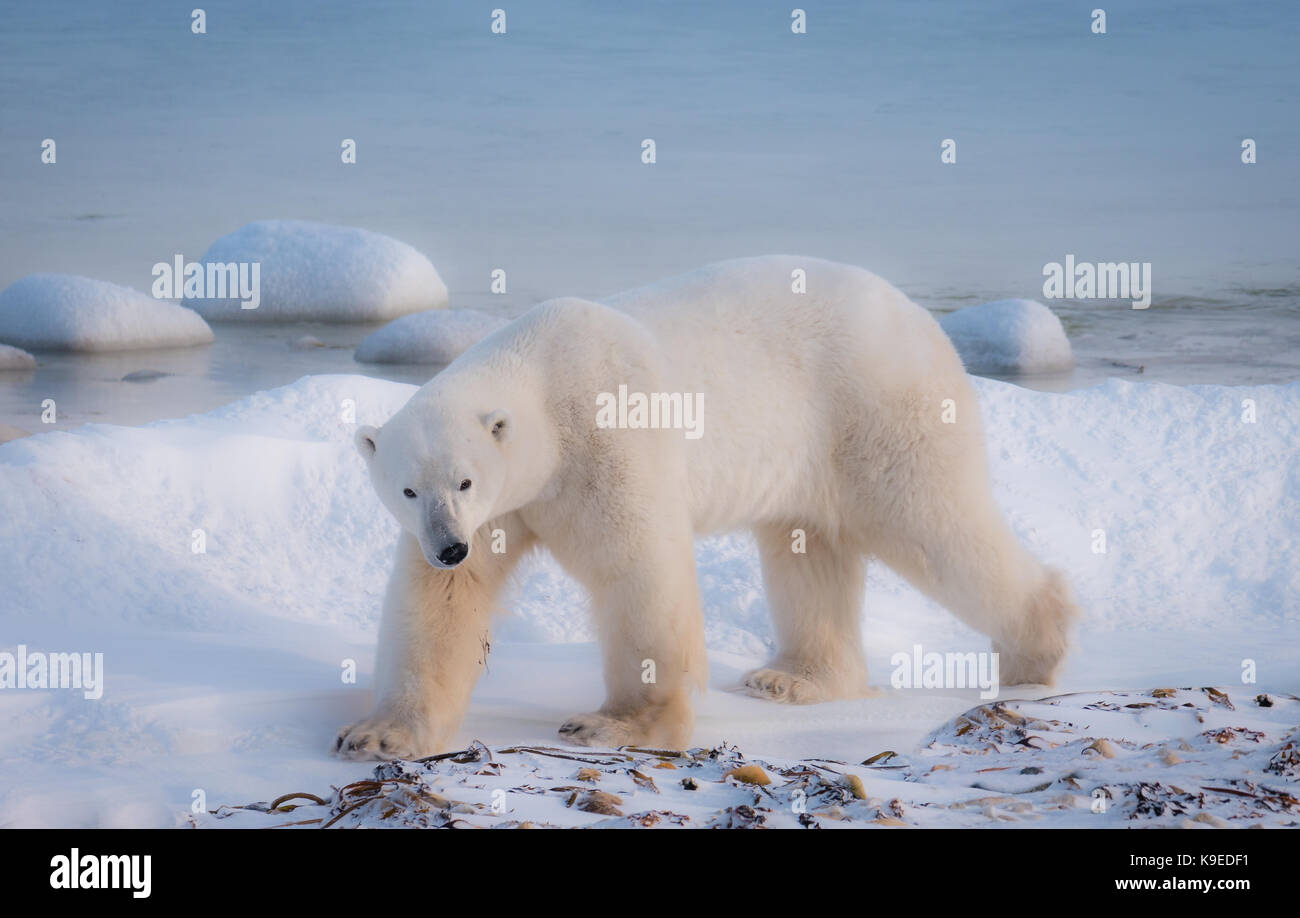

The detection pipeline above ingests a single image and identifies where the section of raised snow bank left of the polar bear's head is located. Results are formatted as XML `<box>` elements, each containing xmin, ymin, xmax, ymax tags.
<box><xmin>0</xmin><ymin>376</ymin><xmax>415</xmax><ymax>628</ymax></box>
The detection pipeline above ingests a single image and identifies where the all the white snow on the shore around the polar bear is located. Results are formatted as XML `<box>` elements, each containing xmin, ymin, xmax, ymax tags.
<box><xmin>0</xmin><ymin>376</ymin><xmax>1300</xmax><ymax>826</ymax></box>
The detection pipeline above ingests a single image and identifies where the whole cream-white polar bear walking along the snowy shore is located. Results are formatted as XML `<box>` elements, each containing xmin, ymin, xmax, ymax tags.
<box><xmin>334</xmin><ymin>256</ymin><xmax>1075</xmax><ymax>758</ymax></box>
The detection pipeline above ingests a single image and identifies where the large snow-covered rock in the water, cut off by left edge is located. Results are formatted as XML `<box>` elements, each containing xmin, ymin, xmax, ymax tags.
<box><xmin>0</xmin><ymin>274</ymin><xmax>212</xmax><ymax>351</ymax></box>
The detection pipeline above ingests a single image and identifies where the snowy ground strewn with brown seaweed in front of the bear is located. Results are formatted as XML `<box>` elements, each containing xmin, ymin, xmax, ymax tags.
<box><xmin>190</xmin><ymin>688</ymin><xmax>1300</xmax><ymax>828</ymax></box>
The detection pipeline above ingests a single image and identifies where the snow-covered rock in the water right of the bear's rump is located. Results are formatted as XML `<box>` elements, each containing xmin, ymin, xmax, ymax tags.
<box><xmin>939</xmin><ymin>299</ymin><xmax>1074</xmax><ymax>373</ymax></box>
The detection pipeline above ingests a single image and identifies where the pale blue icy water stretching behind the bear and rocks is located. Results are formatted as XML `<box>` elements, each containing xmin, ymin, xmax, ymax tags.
<box><xmin>0</xmin><ymin>0</ymin><xmax>1300</xmax><ymax>429</ymax></box>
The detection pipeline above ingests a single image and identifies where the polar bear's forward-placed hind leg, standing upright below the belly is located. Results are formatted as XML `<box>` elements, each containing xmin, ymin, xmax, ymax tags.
<box><xmin>744</xmin><ymin>525</ymin><xmax>868</xmax><ymax>705</ymax></box>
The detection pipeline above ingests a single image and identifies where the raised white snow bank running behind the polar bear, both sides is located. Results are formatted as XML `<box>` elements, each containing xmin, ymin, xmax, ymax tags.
<box><xmin>0</xmin><ymin>376</ymin><xmax>1300</xmax><ymax>637</ymax></box>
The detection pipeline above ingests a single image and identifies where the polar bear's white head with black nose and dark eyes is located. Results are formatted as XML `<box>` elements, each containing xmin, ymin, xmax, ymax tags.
<box><xmin>355</xmin><ymin>403</ymin><xmax>514</xmax><ymax>568</ymax></box>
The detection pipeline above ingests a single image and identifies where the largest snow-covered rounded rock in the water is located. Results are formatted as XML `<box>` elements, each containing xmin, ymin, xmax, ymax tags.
<box><xmin>185</xmin><ymin>220</ymin><xmax>447</xmax><ymax>322</ymax></box>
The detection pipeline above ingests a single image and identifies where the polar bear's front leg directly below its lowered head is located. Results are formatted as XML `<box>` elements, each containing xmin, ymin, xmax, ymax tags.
<box><xmin>334</xmin><ymin>516</ymin><xmax>533</xmax><ymax>759</ymax></box>
